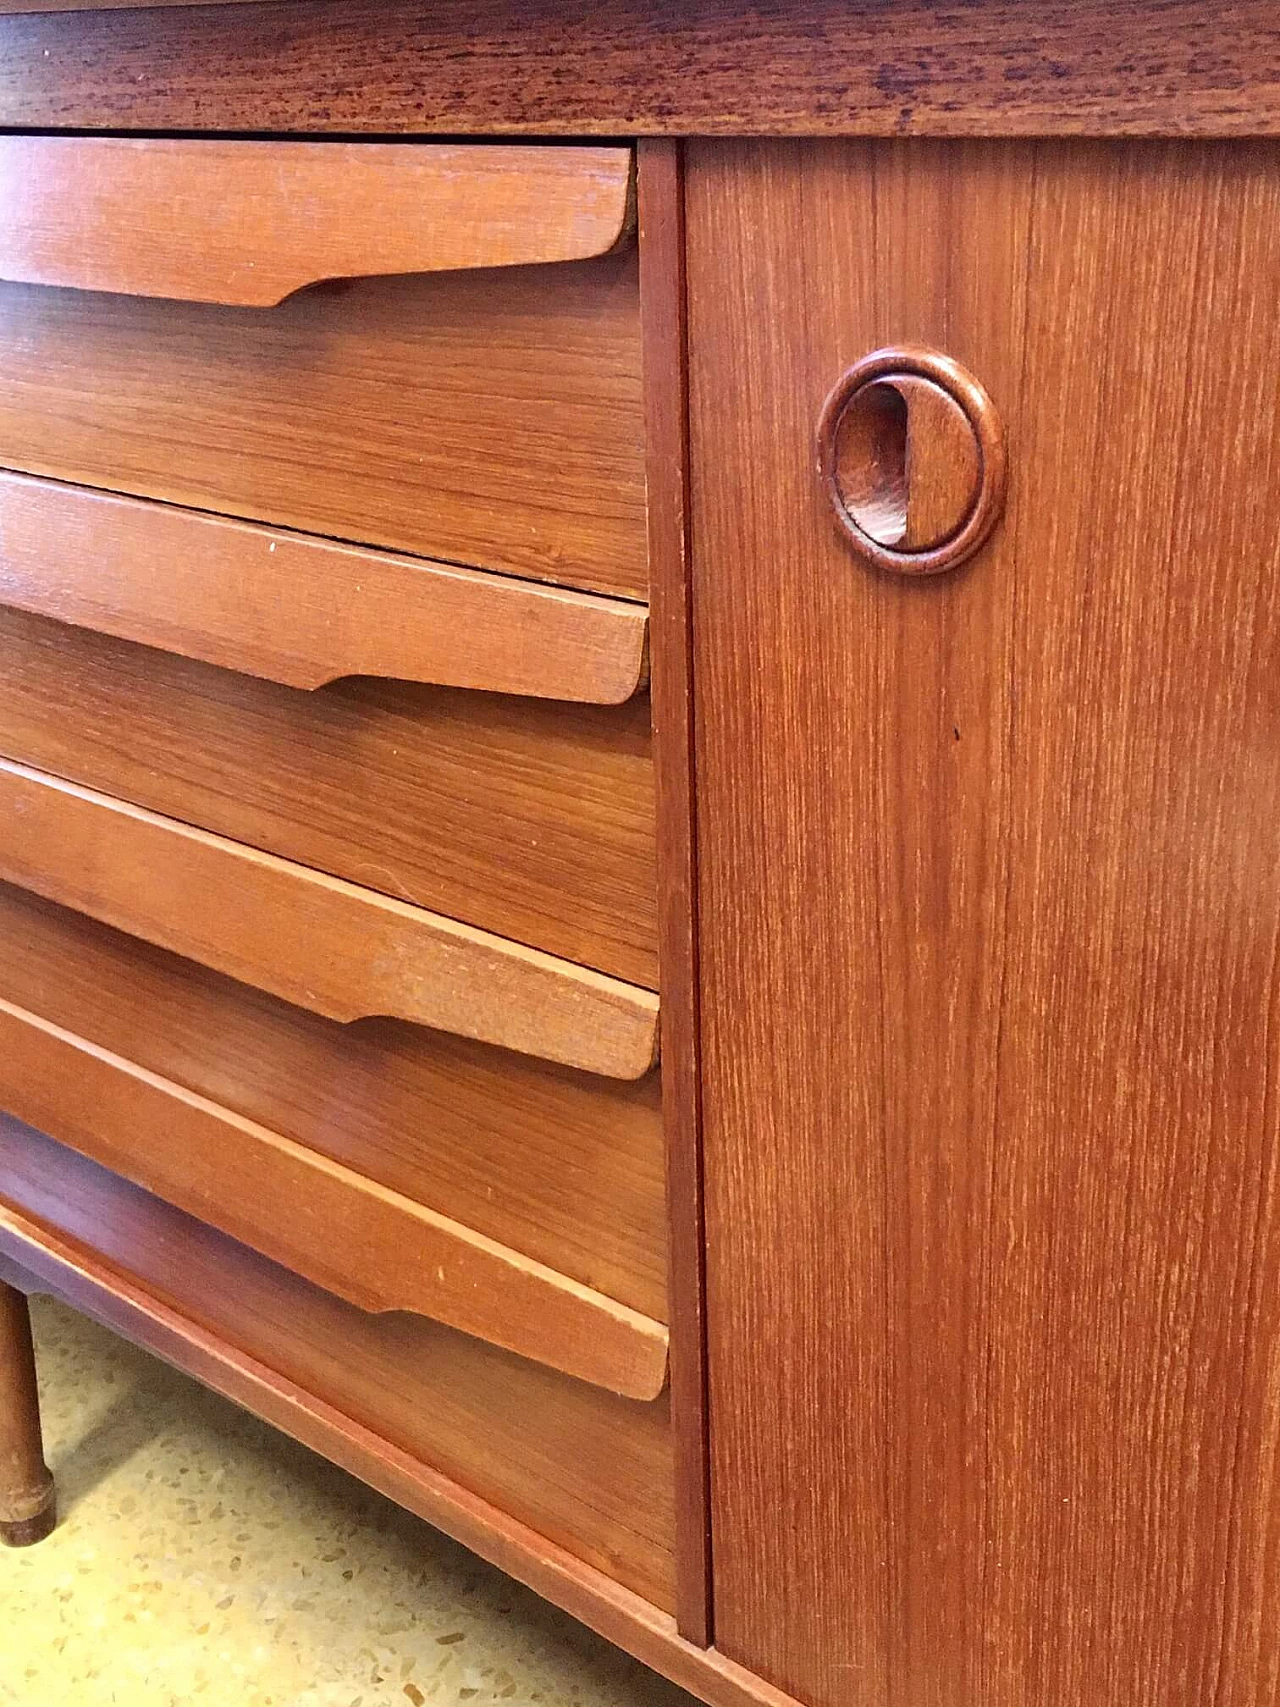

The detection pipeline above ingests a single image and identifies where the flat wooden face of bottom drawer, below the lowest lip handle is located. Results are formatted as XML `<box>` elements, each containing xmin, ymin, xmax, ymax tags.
<box><xmin>0</xmin><ymin>1120</ymin><xmax>672</xmax><ymax>1610</ymax></box>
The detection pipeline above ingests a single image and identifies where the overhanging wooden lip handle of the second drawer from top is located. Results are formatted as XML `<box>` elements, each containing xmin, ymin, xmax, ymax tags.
<box><xmin>0</xmin><ymin>473</ymin><xmax>649</xmax><ymax>705</ymax></box>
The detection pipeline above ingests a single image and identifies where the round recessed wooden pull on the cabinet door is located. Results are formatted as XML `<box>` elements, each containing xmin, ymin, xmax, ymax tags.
<box><xmin>817</xmin><ymin>347</ymin><xmax>1005</xmax><ymax>575</ymax></box>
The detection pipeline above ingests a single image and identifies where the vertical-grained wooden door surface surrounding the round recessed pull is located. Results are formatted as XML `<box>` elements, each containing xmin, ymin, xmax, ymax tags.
<box><xmin>686</xmin><ymin>133</ymin><xmax>1280</xmax><ymax>1707</ymax></box>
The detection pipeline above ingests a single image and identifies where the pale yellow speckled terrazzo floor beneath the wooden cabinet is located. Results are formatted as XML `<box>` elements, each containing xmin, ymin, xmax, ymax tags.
<box><xmin>0</xmin><ymin>1297</ymin><xmax>693</xmax><ymax>1707</ymax></box>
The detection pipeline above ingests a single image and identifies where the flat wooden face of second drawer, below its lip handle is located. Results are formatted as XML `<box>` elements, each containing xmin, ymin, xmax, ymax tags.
<box><xmin>0</xmin><ymin>608</ymin><xmax>657</xmax><ymax>988</ymax></box>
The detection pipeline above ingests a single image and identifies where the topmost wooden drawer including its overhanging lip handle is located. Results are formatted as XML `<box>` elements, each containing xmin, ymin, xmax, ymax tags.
<box><xmin>0</xmin><ymin>137</ymin><xmax>647</xmax><ymax>597</ymax></box>
